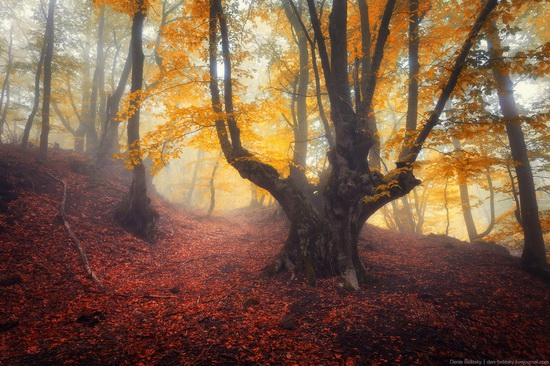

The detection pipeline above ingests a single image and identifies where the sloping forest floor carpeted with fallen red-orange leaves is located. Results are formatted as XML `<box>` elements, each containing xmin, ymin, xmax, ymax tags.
<box><xmin>0</xmin><ymin>147</ymin><xmax>550</xmax><ymax>365</ymax></box>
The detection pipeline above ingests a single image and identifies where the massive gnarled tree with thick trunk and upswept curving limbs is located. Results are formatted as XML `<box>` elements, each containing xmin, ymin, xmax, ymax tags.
<box><xmin>209</xmin><ymin>0</ymin><xmax>497</xmax><ymax>289</ymax></box>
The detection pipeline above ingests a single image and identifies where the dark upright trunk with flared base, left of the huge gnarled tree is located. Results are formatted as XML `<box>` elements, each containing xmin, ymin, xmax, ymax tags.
<box><xmin>115</xmin><ymin>0</ymin><xmax>159</xmax><ymax>240</ymax></box>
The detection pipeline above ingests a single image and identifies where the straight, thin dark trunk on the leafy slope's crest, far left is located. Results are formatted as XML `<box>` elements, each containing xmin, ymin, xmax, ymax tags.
<box><xmin>38</xmin><ymin>0</ymin><xmax>56</xmax><ymax>162</ymax></box>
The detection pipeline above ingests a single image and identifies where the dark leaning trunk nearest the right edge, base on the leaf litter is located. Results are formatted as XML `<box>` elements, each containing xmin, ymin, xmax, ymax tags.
<box><xmin>487</xmin><ymin>22</ymin><xmax>549</xmax><ymax>276</ymax></box>
